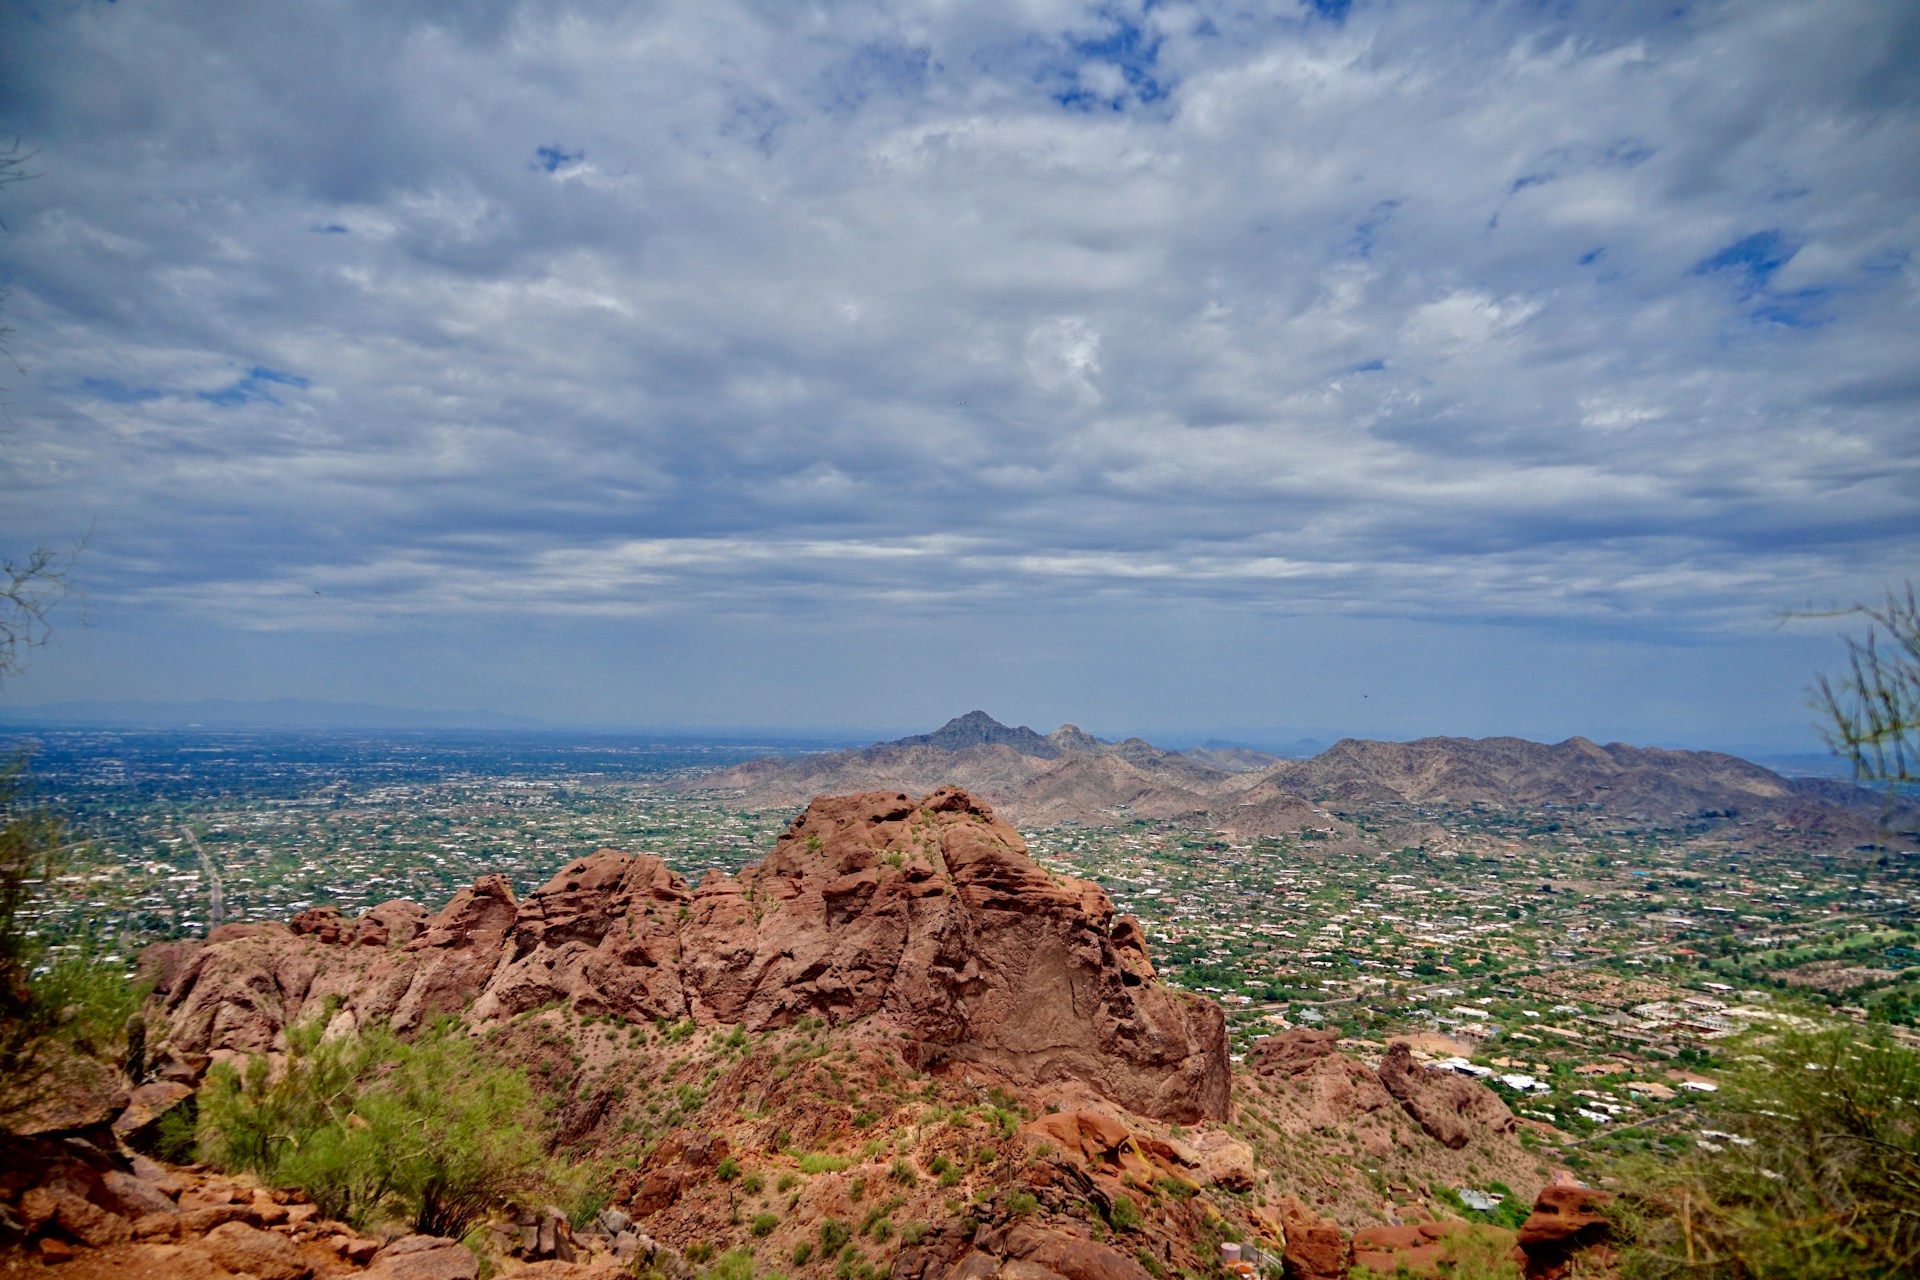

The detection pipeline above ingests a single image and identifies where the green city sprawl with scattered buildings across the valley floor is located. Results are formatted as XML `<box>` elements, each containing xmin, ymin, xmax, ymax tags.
<box><xmin>13</xmin><ymin>731</ymin><xmax>1920</xmax><ymax>1165</ymax></box>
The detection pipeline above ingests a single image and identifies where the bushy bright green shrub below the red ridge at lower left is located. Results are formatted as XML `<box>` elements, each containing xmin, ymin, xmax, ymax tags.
<box><xmin>200</xmin><ymin>1019</ymin><xmax>541</xmax><ymax>1240</ymax></box>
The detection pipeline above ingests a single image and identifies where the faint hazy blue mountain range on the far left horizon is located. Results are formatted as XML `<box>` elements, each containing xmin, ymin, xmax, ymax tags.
<box><xmin>0</xmin><ymin>699</ymin><xmax>545</xmax><ymax>729</ymax></box>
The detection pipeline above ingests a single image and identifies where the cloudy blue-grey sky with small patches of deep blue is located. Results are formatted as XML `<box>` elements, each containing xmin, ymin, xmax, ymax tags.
<box><xmin>0</xmin><ymin>0</ymin><xmax>1920</xmax><ymax>747</ymax></box>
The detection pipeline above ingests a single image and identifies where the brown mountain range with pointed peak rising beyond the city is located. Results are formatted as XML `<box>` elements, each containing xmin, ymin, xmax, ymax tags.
<box><xmin>687</xmin><ymin>712</ymin><xmax>1880</xmax><ymax>839</ymax></box>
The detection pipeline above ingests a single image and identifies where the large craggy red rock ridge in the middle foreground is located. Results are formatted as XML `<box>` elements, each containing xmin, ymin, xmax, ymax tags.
<box><xmin>156</xmin><ymin>787</ymin><xmax>1229</xmax><ymax>1121</ymax></box>
